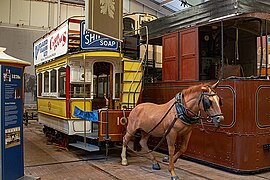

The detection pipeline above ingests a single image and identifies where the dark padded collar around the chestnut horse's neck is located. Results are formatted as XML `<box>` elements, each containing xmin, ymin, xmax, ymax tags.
<box><xmin>175</xmin><ymin>92</ymin><xmax>200</xmax><ymax>125</ymax></box>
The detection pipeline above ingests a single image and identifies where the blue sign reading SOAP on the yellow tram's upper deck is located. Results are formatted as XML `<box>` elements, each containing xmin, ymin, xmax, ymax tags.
<box><xmin>81</xmin><ymin>21</ymin><xmax>118</xmax><ymax>50</ymax></box>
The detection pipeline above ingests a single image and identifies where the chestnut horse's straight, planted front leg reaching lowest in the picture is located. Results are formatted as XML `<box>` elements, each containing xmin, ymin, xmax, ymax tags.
<box><xmin>166</xmin><ymin>132</ymin><xmax>179</xmax><ymax>180</ymax></box>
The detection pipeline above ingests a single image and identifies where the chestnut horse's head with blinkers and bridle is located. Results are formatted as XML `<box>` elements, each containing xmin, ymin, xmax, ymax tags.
<box><xmin>199</xmin><ymin>82</ymin><xmax>224</xmax><ymax>127</ymax></box>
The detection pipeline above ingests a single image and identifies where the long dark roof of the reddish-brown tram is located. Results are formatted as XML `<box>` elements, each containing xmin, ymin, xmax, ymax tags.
<box><xmin>143</xmin><ymin>0</ymin><xmax>270</xmax><ymax>39</ymax></box>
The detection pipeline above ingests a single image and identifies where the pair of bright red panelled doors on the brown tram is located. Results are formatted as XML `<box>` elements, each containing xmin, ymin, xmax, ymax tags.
<box><xmin>162</xmin><ymin>28</ymin><xmax>199</xmax><ymax>81</ymax></box>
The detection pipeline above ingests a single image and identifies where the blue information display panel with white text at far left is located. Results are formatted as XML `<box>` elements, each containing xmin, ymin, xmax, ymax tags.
<box><xmin>0</xmin><ymin>65</ymin><xmax>24</xmax><ymax>180</ymax></box>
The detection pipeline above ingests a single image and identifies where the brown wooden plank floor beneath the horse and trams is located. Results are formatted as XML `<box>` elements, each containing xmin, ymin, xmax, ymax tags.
<box><xmin>24</xmin><ymin>121</ymin><xmax>270</xmax><ymax>180</ymax></box>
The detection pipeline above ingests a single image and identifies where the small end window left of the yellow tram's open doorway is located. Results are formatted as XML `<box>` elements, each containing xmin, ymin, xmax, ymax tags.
<box><xmin>70</xmin><ymin>83</ymin><xmax>91</xmax><ymax>98</ymax></box>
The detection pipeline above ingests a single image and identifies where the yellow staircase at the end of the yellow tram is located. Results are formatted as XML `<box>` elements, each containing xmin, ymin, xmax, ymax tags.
<box><xmin>121</xmin><ymin>60</ymin><xmax>144</xmax><ymax>110</ymax></box>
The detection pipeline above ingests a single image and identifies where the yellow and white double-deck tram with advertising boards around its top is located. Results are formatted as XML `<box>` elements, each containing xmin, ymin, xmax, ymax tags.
<box><xmin>33</xmin><ymin>13</ymin><xmax>156</xmax><ymax>151</ymax></box>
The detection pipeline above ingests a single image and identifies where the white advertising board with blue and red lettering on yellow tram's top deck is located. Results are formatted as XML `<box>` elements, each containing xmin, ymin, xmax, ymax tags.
<box><xmin>34</xmin><ymin>23</ymin><xmax>68</xmax><ymax>65</ymax></box>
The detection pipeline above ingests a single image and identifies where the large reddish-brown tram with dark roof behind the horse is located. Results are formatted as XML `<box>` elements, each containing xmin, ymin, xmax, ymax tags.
<box><xmin>137</xmin><ymin>0</ymin><xmax>270</xmax><ymax>176</ymax></box>
